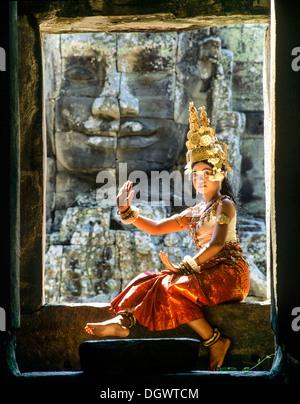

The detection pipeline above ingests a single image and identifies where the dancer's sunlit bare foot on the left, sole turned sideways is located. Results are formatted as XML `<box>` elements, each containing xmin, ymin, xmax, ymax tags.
<box><xmin>85</xmin><ymin>315</ymin><xmax>130</xmax><ymax>338</ymax></box>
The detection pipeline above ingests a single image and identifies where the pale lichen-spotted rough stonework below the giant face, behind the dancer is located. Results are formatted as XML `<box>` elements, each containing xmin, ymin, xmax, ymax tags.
<box><xmin>45</xmin><ymin>197</ymin><xmax>267</xmax><ymax>303</ymax></box>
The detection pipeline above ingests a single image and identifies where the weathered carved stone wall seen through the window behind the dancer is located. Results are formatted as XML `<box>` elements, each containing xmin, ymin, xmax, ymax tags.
<box><xmin>44</xmin><ymin>26</ymin><xmax>266</xmax><ymax>302</ymax></box>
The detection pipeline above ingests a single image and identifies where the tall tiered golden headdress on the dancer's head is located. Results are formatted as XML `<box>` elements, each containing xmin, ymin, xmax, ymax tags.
<box><xmin>185</xmin><ymin>102</ymin><xmax>232</xmax><ymax>181</ymax></box>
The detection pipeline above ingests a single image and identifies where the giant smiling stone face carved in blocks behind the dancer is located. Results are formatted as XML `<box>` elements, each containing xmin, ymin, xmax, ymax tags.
<box><xmin>55</xmin><ymin>34</ymin><xmax>190</xmax><ymax>176</ymax></box>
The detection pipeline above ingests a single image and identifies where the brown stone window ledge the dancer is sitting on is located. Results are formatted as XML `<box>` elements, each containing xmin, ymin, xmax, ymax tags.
<box><xmin>16</xmin><ymin>302</ymin><xmax>275</xmax><ymax>372</ymax></box>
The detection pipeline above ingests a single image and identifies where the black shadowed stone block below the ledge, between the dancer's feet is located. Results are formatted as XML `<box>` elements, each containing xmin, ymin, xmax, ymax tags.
<box><xmin>79</xmin><ymin>338</ymin><xmax>200</xmax><ymax>374</ymax></box>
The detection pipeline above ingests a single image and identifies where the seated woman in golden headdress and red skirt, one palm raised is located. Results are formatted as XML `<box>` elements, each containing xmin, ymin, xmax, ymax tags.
<box><xmin>85</xmin><ymin>103</ymin><xmax>250</xmax><ymax>371</ymax></box>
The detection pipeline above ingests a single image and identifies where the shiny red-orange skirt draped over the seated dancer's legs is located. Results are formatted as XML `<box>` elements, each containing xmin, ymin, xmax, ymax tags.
<box><xmin>111</xmin><ymin>243</ymin><xmax>250</xmax><ymax>331</ymax></box>
